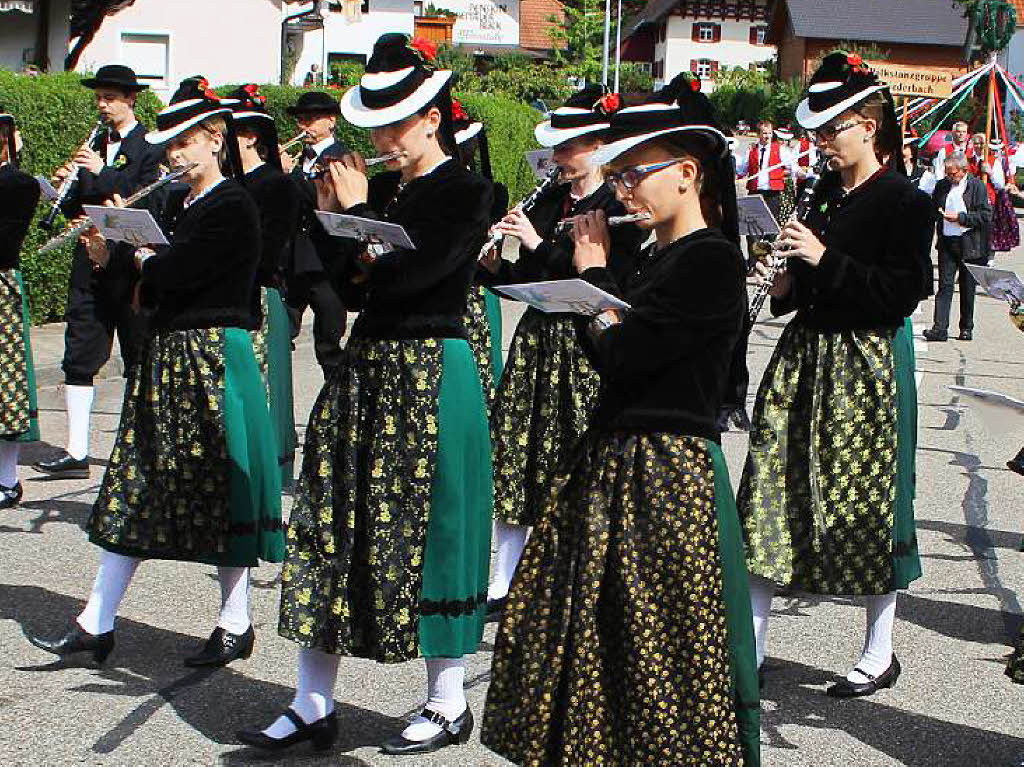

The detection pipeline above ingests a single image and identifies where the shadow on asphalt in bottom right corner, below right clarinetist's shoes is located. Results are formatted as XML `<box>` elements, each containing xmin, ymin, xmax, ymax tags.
<box><xmin>761</xmin><ymin>658</ymin><xmax>1024</xmax><ymax>767</ymax></box>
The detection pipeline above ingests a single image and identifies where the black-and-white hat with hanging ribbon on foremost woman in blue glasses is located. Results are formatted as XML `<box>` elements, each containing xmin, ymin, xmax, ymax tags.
<box><xmin>591</xmin><ymin>73</ymin><xmax>739</xmax><ymax>245</ymax></box>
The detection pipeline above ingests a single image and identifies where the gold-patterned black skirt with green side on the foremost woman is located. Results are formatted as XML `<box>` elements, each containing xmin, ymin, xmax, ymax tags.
<box><xmin>481</xmin><ymin>433</ymin><xmax>760</xmax><ymax>767</ymax></box>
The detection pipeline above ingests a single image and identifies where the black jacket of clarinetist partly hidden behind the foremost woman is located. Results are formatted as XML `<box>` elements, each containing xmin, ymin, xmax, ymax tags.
<box><xmin>489</xmin><ymin>183</ymin><xmax>646</xmax><ymax>285</ymax></box>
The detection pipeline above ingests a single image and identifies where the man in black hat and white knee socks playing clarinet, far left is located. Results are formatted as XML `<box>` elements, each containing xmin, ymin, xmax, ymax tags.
<box><xmin>35</xmin><ymin>65</ymin><xmax>162</xmax><ymax>478</ymax></box>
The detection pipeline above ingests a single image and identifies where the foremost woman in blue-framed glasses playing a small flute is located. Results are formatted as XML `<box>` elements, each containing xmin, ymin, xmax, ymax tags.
<box><xmin>481</xmin><ymin>75</ymin><xmax>760</xmax><ymax>767</ymax></box>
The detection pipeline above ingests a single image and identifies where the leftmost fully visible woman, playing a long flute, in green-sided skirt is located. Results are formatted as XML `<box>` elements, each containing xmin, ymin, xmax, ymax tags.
<box><xmin>30</xmin><ymin>92</ymin><xmax>285</xmax><ymax>666</ymax></box>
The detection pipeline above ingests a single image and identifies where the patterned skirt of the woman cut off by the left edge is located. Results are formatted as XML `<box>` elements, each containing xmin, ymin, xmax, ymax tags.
<box><xmin>0</xmin><ymin>269</ymin><xmax>39</xmax><ymax>442</ymax></box>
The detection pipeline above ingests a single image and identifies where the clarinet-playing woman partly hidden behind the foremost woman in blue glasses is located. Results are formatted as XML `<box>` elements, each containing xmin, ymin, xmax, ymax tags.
<box><xmin>483</xmin><ymin>86</ymin><xmax>643</xmax><ymax>613</ymax></box>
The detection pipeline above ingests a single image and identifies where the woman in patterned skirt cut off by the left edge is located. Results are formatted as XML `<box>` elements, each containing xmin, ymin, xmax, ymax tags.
<box><xmin>0</xmin><ymin>108</ymin><xmax>39</xmax><ymax>509</ymax></box>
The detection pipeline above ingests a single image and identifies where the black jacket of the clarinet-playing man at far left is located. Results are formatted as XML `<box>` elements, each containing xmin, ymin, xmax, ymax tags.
<box><xmin>63</xmin><ymin>123</ymin><xmax>164</xmax><ymax>290</ymax></box>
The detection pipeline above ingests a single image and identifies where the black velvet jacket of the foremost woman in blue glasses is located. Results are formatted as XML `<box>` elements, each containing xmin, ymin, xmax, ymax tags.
<box><xmin>583</xmin><ymin>228</ymin><xmax>746</xmax><ymax>441</ymax></box>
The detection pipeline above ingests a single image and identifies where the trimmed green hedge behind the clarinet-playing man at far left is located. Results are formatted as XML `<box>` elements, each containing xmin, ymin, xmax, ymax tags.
<box><xmin>0</xmin><ymin>70</ymin><xmax>160</xmax><ymax>323</ymax></box>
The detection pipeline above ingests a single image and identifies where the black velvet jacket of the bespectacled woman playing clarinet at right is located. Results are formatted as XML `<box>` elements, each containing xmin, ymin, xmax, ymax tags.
<box><xmin>771</xmin><ymin>169</ymin><xmax>934</xmax><ymax>333</ymax></box>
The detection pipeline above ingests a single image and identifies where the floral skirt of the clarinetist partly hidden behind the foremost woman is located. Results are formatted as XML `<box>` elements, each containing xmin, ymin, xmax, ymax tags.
<box><xmin>490</xmin><ymin>308</ymin><xmax>600</xmax><ymax>525</ymax></box>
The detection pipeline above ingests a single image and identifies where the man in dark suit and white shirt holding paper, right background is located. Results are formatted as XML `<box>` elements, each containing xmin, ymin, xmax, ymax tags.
<box><xmin>925</xmin><ymin>155</ymin><xmax>992</xmax><ymax>341</ymax></box>
